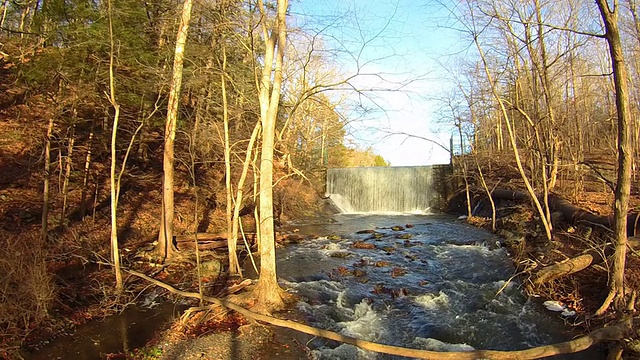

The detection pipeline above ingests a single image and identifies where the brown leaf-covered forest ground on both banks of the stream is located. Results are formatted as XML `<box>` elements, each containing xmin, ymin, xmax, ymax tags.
<box><xmin>0</xmin><ymin>91</ymin><xmax>640</xmax><ymax>360</ymax></box>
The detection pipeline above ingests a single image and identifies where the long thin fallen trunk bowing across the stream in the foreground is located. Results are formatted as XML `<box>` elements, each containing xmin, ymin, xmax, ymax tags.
<box><xmin>126</xmin><ymin>270</ymin><xmax>633</xmax><ymax>360</ymax></box>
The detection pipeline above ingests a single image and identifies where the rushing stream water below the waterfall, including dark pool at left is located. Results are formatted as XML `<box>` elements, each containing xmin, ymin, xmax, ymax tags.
<box><xmin>24</xmin><ymin>214</ymin><xmax>603</xmax><ymax>360</ymax></box>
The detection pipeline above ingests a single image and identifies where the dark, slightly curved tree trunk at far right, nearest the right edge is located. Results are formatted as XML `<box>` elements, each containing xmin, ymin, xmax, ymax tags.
<box><xmin>596</xmin><ymin>0</ymin><xmax>631</xmax><ymax>314</ymax></box>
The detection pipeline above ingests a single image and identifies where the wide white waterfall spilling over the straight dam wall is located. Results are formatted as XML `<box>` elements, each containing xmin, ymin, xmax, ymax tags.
<box><xmin>326</xmin><ymin>165</ymin><xmax>451</xmax><ymax>213</ymax></box>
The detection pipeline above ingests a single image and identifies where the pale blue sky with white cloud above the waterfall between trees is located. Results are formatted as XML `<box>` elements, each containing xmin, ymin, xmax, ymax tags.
<box><xmin>290</xmin><ymin>0</ymin><xmax>464</xmax><ymax>166</ymax></box>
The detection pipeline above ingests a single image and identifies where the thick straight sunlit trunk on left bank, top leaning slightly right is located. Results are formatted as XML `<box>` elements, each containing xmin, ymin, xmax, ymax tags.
<box><xmin>157</xmin><ymin>0</ymin><xmax>193</xmax><ymax>259</ymax></box>
